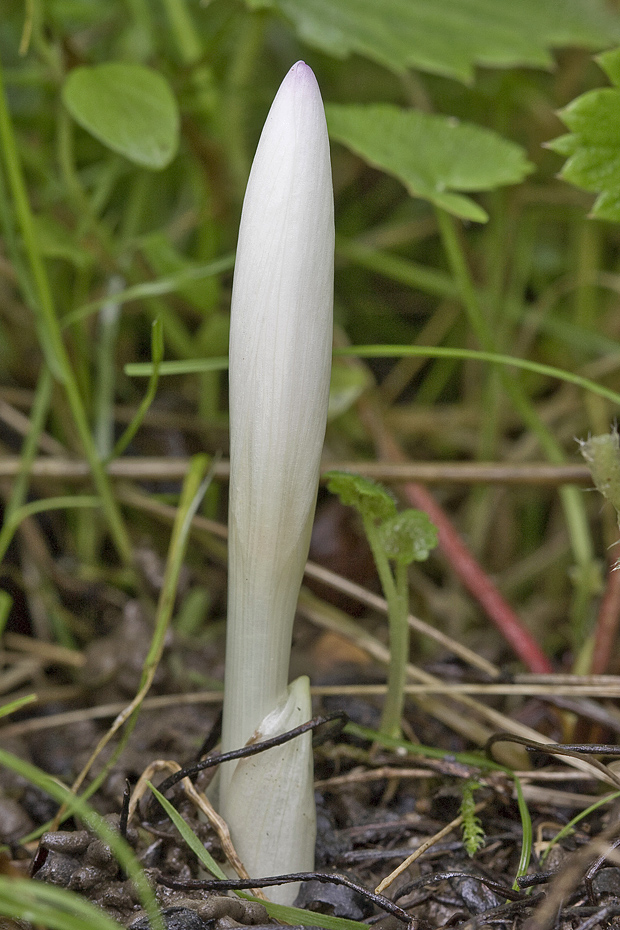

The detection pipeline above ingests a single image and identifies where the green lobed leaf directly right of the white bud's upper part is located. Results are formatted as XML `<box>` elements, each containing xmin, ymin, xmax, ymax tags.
<box><xmin>326</xmin><ymin>104</ymin><xmax>533</xmax><ymax>223</ymax></box>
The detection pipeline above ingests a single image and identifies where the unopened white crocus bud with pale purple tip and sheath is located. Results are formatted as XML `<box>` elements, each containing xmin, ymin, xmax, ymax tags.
<box><xmin>220</xmin><ymin>61</ymin><xmax>334</xmax><ymax>903</ymax></box>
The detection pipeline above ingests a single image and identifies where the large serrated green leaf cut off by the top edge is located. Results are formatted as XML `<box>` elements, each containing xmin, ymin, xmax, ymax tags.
<box><xmin>252</xmin><ymin>0</ymin><xmax>620</xmax><ymax>81</ymax></box>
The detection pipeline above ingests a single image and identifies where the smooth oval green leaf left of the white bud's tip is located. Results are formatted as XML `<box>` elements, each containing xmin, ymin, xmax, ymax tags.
<box><xmin>63</xmin><ymin>62</ymin><xmax>179</xmax><ymax>170</ymax></box>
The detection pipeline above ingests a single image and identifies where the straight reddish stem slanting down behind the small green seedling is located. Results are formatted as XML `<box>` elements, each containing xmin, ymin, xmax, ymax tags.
<box><xmin>360</xmin><ymin>404</ymin><xmax>556</xmax><ymax>674</ymax></box>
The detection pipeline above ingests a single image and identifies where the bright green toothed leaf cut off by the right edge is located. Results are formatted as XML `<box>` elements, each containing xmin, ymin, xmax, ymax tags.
<box><xmin>548</xmin><ymin>49</ymin><xmax>620</xmax><ymax>222</ymax></box>
